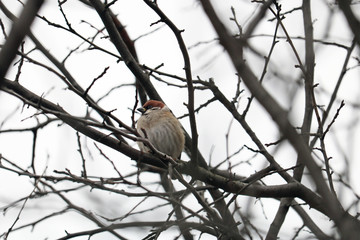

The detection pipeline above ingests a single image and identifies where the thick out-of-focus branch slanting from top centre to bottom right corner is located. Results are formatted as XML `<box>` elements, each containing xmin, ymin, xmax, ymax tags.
<box><xmin>201</xmin><ymin>0</ymin><xmax>360</xmax><ymax>236</ymax></box>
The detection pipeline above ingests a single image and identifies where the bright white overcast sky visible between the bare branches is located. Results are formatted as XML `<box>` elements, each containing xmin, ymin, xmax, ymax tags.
<box><xmin>0</xmin><ymin>0</ymin><xmax>360</xmax><ymax>239</ymax></box>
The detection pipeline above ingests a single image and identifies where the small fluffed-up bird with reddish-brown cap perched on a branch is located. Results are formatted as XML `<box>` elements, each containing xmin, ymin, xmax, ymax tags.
<box><xmin>136</xmin><ymin>100</ymin><xmax>185</xmax><ymax>160</ymax></box>
